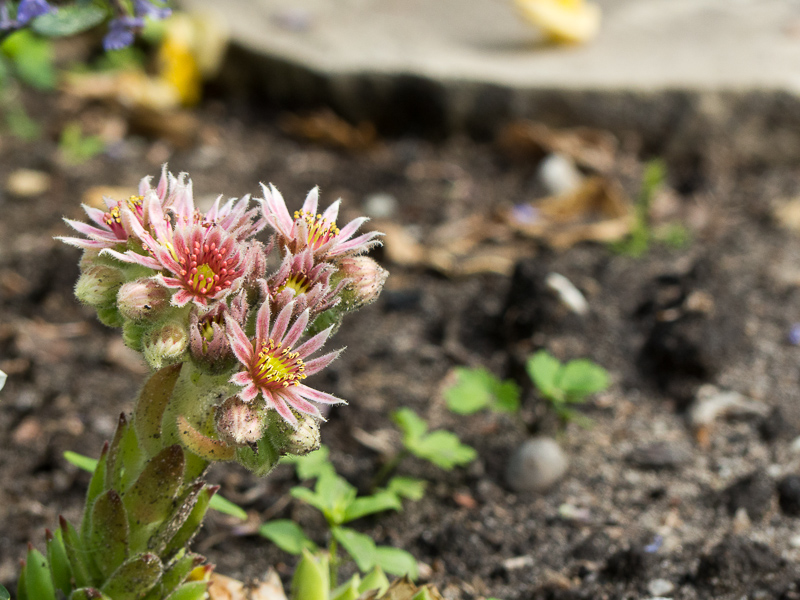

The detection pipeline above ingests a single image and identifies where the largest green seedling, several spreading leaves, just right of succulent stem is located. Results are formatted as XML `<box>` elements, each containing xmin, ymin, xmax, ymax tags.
<box><xmin>268</xmin><ymin>446</ymin><xmax>425</xmax><ymax>587</ymax></box>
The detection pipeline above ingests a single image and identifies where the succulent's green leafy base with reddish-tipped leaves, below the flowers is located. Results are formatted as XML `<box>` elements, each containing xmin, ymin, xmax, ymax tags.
<box><xmin>17</xmin><ymin>365</ymin><xmax>216</xmax><ymax>600</ymax></box>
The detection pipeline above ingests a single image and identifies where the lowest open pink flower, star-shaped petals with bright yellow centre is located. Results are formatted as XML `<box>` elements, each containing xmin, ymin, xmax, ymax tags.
<box><xmin>225</xmin><ymin>302</ymin><xmax>344</xmax><ymax>427</ymax></box>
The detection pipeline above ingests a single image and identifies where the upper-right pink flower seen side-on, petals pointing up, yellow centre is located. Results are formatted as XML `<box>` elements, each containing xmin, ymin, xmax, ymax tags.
<box><xmin>261</xmin><ymin>183</ymin><xmax>382</xmax><ymax>260</ymax></box>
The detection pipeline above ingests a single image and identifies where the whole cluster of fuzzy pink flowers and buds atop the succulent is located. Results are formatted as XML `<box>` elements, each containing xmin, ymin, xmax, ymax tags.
<box><xmin>59</xmin><ymin>166</ymin><xmax>387</xmax><ymax>468</ymax></box>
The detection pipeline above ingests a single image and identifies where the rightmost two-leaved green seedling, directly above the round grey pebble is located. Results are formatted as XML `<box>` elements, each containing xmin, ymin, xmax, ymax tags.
<box><xmin>525</xmin><ymin>350</ymin><xmax>608</xmax><ymax>421</ymax></box>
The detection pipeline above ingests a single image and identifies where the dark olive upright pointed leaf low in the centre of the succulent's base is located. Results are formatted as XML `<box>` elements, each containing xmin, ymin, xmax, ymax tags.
<box><xmin>90</xmin><ymin>490</ymin><xmax>129</xmax><ymax>577</ymax></box>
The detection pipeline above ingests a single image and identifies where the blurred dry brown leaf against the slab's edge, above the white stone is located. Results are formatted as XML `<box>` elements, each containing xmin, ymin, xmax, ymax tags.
<box><xmin>497</xmin><ymin>120</ymin><xmax>617</xmax><ymax>173</ymax></box>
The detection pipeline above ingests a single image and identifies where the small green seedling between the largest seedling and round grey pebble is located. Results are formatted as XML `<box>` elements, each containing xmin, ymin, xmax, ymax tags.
<box><xmin>392</xmin><ymin>408</ymin><xmax>477</xmax><ymax>471</ymax></box>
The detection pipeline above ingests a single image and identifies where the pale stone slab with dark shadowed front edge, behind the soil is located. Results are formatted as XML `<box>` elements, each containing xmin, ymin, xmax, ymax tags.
<box><xmin>183</xmin><ymin>0</ymin><xmax>800</xmax><ymax>162</ymax></box>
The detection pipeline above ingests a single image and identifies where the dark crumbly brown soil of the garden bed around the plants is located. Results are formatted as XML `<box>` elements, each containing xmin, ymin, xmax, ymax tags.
<box><xmin>0</xmin><ymin>90</ymin><xmax>800</xmax><ymax>600</ymax></box>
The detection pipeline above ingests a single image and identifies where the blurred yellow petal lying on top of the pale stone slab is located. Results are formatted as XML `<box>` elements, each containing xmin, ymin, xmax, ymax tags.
<box><xmin>514</xmin><ymin>0</ymin><xmax>600</xmax><ymax>44</ymax></box>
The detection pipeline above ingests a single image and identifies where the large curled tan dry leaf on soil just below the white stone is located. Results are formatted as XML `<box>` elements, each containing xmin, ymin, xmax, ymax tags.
<box><xmin>505</xmin><ymin>177</ymin><xmax>633</xmax><ymax>249</ymax></box>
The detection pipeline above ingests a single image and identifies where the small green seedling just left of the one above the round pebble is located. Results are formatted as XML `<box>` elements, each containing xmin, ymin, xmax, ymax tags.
<box><xmin>444</xmin><ymin>367</ymin><xmax>519</xmax><ymax>415</ymax></box>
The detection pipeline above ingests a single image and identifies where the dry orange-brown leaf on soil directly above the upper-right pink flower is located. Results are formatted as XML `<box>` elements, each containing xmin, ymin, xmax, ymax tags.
<box><xmin>278</xmin><ymin>109</ymin><xmax>378</xmax><ymax>151</ymax></box>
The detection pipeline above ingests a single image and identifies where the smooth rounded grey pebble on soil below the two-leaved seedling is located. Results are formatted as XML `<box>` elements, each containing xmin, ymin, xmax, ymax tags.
<box><xmin>506</xmin><ymin>437</ymin><xmax>569</xmax><ymax>492</ymax></box>
